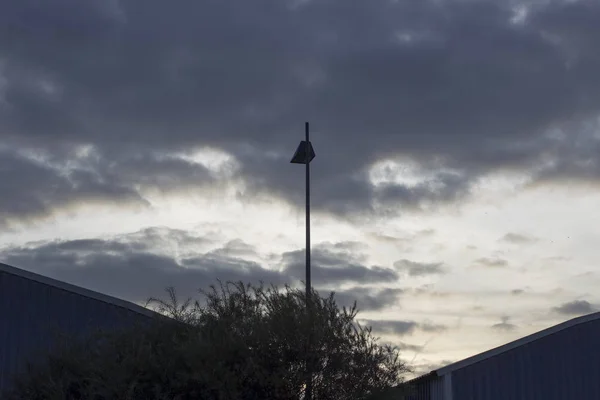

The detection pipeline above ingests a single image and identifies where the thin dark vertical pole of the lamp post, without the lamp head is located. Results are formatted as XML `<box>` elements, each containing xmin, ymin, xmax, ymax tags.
<box><xmin>304</xmin><ymin>122</ymin><xmax>313</xmax><ymax>400</ymax></box>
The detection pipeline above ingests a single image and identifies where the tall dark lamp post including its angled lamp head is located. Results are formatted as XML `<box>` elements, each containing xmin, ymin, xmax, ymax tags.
<box><xmin>291</xmin><ymin>122</ymin><xmax>315</xmax><ymax>400</ymax></box>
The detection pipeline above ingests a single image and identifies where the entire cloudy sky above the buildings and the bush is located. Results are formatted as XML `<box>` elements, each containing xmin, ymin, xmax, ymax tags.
<box><xmin>0</xmin><ymin>0</ymin><xmax>600</xmax><ymax>373</ymax></box>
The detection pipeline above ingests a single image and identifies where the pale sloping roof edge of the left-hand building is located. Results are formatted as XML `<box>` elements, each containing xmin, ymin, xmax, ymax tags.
<box><xmin>0</xmin><ymin>263</ymin><xmax>161</xmax><ymax>318</ymax></box>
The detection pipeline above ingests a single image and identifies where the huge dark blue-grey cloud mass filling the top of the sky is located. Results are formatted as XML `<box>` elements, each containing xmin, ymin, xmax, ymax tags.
<box><xmin>0</xmin><ymin>0</ymin><xmax>600</xmax><ymax>219</ymax></box>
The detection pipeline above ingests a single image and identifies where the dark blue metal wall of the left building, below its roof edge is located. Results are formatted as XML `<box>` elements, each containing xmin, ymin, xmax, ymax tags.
<box><xmin>0</xmin><ymin>271</ymin><xmax>155</xmax><ymax>393</ymax></box>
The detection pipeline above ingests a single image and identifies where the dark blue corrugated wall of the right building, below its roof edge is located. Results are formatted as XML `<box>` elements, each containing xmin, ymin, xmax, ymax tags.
<box><xmin>452</xmin><ymin>319</ymin><xmax>600</xmax><ymax>400</ymax></box>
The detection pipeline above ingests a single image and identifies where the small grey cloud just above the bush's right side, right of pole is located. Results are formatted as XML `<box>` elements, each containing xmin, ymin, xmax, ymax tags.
<box><xmin>328</xmin><ymin>287</ymin><xmax>403</xmax><ymax>311</ymax></box>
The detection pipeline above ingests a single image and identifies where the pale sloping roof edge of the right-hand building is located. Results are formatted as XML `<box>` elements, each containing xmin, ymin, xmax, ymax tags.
<box><xmin>432</xmin><ymin>312</ymin><xmax>600</xmax><ymax>376</ymax></box>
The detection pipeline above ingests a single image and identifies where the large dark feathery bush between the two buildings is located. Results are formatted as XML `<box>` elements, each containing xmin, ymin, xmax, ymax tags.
<box><xmin>8</xmin><ymin>283</ymin><xmax>407</xmax><ymax>400</ymax></box>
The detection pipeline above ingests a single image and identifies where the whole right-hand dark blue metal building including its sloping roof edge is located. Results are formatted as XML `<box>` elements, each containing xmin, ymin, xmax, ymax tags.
<box><xmin>409</xmin><ymin>313</ymin><xmax>600</xmax><ymax>400</ymax></box>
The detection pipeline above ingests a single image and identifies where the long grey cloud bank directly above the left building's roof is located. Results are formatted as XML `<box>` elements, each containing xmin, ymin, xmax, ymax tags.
<box><xmin>0</xmin><ymin>230</ymin><xmax>288</xmax><ymax>301</ymax></box>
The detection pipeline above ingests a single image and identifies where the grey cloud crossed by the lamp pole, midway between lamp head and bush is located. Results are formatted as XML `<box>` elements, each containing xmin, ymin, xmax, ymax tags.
<box><xmin>283</xmin><ymin>244</ymin><xmax>398</xmax><ymax>285</ymax></box>
